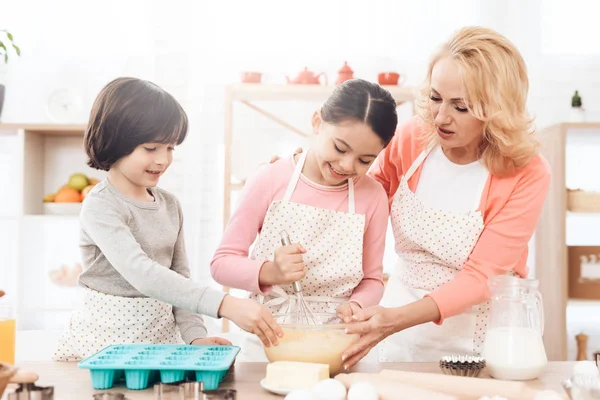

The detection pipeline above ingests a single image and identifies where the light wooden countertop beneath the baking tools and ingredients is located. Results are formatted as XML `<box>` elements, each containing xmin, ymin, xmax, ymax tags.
<box><xmin>2</xmin><ymin>361</ymin><xmax>574</xmax><ymax>400</ymax></box>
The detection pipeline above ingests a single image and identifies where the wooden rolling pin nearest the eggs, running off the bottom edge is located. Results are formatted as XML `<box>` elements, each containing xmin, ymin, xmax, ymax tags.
<box><xmin>335</xmin><ymin>372</ymin><xmax>458</xmax><ymax>400</ymax></box>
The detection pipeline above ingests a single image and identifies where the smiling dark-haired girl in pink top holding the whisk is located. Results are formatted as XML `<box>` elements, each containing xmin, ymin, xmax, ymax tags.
<box><xmin>211</xmin><ymin>79</ymin><xmax>398</xmax><ymax>361</ymax></box>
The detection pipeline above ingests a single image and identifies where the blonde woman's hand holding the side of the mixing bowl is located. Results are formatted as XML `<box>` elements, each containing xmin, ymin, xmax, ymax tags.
<box><xmin>342</xmin><ymin>306</ymin><xmax>398</xmax><ymax>370</ymax></box>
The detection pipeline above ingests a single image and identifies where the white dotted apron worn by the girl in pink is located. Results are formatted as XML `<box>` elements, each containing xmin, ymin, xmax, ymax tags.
<box><xmin>239</xmin><ymin>150</ymin><xmax>365</xmax><ymax>362</ymax></box>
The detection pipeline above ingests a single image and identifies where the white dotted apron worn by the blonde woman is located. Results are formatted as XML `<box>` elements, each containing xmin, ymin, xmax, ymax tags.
<box><xmin>378</xmin><ymin>147</ymin><xmax>489</xmax><ymax>362</ymax></box>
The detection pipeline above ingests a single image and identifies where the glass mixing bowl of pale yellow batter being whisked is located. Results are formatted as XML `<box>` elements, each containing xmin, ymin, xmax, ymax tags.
<box><xmin>263</xmin><ymin>313</ymin><xmax>359</xmax><ymax>376</ymax></box>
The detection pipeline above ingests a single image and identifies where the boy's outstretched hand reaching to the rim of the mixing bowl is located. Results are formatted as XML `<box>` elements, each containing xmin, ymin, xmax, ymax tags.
<box><xmin>219</xmin><ymin>295</ymin><xmax>283</xmax><ymax>347</ymax></box>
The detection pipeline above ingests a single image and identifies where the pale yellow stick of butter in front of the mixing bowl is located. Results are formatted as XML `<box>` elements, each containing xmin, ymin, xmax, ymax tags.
<box><xmin>265</xmin><ymin>361</ymin><xmax>329</xmax><ymax>389</ymax></box>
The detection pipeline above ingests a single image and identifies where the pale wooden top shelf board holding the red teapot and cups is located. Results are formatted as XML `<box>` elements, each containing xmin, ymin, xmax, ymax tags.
<box><xmin>226</xmin><ymin>83</ymin><xmax>415</xmax><ymax>102</ymax></box>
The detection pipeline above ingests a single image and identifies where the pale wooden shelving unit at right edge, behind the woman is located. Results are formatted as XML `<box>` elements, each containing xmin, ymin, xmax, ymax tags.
<box><xmin>535</xmin><ymin>122</ymin><xmax>600</xmax><ymax>360</ymax></box>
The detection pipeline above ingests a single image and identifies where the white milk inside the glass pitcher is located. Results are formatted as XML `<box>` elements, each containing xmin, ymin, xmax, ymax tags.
<box><xmin>483</xmin><ymin>327</ymin><xmax>548</xmax><ymax>380</ymax></box>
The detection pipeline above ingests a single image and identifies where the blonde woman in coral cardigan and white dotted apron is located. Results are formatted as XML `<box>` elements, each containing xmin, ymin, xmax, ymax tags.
<box><xmin>343</xmin><ymin>27</ymin><xmax>550</xmax><ymax>368</ymax></box>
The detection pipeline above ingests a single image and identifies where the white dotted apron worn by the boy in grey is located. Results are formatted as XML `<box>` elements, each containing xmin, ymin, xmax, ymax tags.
<box><xmin>52</xmin><ymin>288</ymin><xmax>184</xmax><ymax>361</ymax></box>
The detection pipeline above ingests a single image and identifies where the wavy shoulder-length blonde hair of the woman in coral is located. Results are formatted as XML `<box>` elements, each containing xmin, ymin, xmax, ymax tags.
<box><xmin>417</xmin><ymin>26</ymin><xmax>538</xmax><ymax>176</ymax></box>
